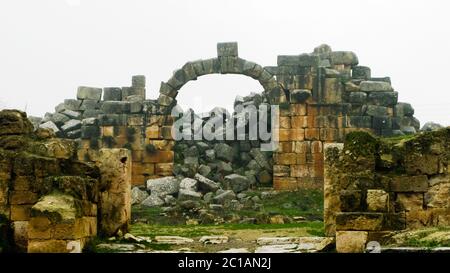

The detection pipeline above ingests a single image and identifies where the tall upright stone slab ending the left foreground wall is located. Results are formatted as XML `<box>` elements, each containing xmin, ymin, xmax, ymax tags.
<box><xmin>96</xmin><ymin>149</ymin><xmax>131</xmax><ymax>236</ymax></box>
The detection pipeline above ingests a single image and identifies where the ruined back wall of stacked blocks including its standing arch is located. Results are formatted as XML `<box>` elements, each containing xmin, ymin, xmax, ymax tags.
<box><xmin>32</xmin><ymin>43</ymin><xmax>419</xmax><ymax>189</ymax></box>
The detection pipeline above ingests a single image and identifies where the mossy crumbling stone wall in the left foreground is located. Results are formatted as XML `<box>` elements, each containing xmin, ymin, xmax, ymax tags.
<box><xmin>0</xmin><ymin>110</ymin><xmax>131</xmax><ymax>252</ymax></box>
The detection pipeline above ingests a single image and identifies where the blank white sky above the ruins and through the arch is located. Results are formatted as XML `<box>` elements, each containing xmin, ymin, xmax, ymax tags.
<box><xmin>0</xmin><ymin>0</ymin><xmax>450</xmax><ymax>125</ymax></box>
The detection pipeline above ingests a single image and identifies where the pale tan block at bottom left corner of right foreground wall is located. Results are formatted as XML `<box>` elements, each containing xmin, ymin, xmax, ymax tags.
<box><xmin>336</xmin><ymin>231</ymin><xmax>368</xmax><ymax>253</ymax></box>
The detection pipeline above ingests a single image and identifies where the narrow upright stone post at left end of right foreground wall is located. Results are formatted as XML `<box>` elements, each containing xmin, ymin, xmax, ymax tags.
<box><xmin>323</xmin><ymin>143</ymin><xmax>344</xmax><ymax>236</ymax></box>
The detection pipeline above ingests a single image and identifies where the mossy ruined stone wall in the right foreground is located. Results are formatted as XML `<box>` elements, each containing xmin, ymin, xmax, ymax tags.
<box><xmin>324</xmin><ymin>128</ymin><xmax>450</xmax><ymax>252</ymax></box>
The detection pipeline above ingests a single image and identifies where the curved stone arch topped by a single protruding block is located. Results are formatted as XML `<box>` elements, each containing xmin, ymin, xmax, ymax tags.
<box><xmin>158</xmin><ymin>42</ymin><xmax>287</xmax><ymax>109</ymax></box>
